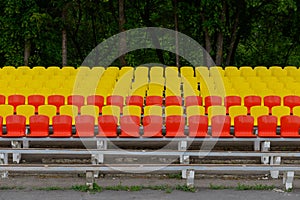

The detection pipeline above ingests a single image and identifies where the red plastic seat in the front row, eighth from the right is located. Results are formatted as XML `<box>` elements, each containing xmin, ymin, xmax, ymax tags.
<box><xmin>120</xmin><ymin>115</ymin><xmax>140</xmax><ymax>137</ymax></box>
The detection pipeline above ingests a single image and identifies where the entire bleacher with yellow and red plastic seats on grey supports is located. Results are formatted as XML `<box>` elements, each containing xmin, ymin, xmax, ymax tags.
<box><xmin>0</xmin><ymin>66</ymin><xmax>300</xmax><ymax>189</ymax></box>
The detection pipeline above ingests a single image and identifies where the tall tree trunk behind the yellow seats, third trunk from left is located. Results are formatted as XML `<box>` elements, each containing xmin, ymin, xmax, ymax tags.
<box><xmin>119</xmin><ymin>0</ymin><xmax>126</xmax><ymax>66</ymax></box>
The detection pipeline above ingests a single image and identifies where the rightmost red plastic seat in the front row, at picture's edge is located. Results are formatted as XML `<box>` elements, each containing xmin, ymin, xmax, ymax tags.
<box><xmin>280</xmin><ymin>115</ymin><xmax>300</xmax><ymax>138</ymax></box>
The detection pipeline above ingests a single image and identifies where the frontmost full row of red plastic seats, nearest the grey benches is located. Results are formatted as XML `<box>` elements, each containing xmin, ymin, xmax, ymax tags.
<box><xmin>0</xmin><ymin>115</ymin><xmax>300</xmax><ymax>138</ymax></box>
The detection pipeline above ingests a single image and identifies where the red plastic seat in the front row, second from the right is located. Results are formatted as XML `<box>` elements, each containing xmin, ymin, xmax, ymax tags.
<box><xmin>257</xmin><ymin>115</ymin><xmax>280</xmax><ymax>138</ymax></box>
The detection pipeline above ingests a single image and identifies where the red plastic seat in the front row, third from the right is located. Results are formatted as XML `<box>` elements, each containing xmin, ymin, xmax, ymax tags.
<box><xmin>234</xmin><ymin>115</ymin><xmax>256</xmax><ymax>138</ymax></box>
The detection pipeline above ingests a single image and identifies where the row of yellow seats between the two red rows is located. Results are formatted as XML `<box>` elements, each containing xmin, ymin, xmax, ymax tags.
<box><xmin>0</xmin><ymin>105</ymin><xmax>300</xmax><ymax>126</ymax></box>
